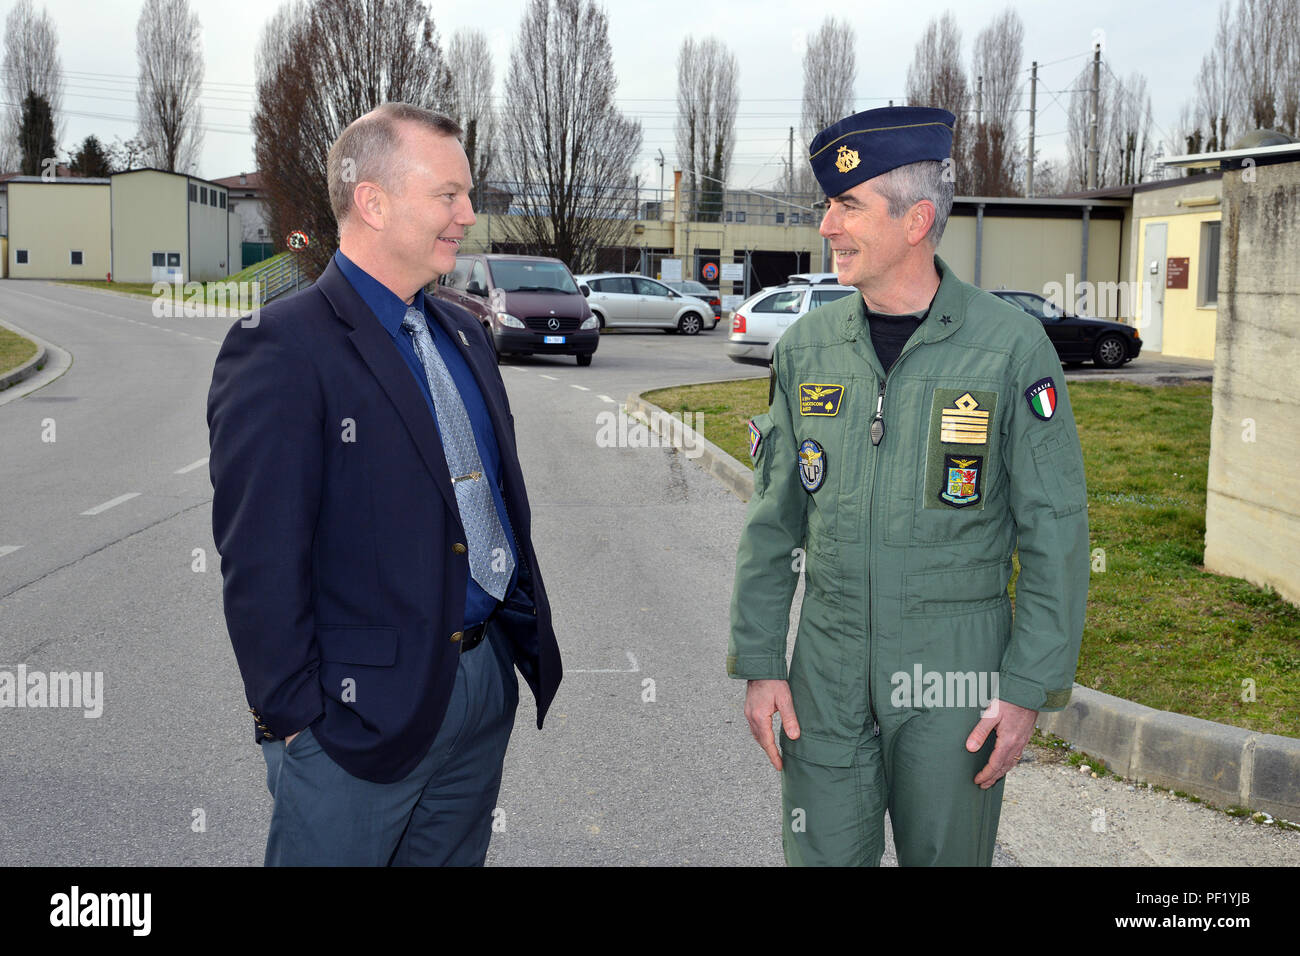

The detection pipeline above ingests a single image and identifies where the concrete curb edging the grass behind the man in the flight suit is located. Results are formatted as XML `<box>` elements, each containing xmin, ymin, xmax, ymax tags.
<box><xmin>627</xmin><ymin>386</ymin><xmax>1300</xmax><ymax>822</ymax></box>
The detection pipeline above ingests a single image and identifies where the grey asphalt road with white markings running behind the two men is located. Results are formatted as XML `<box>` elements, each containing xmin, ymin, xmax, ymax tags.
<box><xmin>0</xmin><ymin>281</ymin><xmax>1300</xmax><ymax>865</ymax></box>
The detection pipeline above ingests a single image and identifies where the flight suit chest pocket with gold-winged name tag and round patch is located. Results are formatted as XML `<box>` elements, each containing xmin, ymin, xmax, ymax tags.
<box><xmin>790</xmin><ymin>373</ymin><xmax>866</xmax><ymax>541</ymax></box>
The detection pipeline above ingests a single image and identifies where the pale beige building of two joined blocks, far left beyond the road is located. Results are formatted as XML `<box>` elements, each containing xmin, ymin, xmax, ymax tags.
<box><xmin>5</xmin><ymin>169</ymin><xmax>241</xmax><ymax>282</ymax></box>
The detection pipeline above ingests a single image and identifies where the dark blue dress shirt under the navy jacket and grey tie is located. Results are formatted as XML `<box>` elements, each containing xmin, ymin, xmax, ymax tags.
<box><xmin>334</xmin><ymin>251</ymin><xmax>519</xmax><ymax>627</ymax></box>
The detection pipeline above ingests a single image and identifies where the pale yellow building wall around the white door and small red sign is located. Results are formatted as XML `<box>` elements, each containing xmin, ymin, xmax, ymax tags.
<box><xmin>1130</xmin><ymin>177</ymin><xmax>1223</xmax><ymax>359</ymax></box>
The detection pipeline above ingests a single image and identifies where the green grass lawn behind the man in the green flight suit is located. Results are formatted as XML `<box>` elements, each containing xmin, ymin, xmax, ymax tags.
<box><xmin>646</xmin><ymin>377</ymin><xmax>1300</xmax><ymax>737</ymax></box>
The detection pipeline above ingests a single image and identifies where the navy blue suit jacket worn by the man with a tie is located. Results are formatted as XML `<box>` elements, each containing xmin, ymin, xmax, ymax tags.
<box><xmin>208</xmin><ymin>256</ymin><xmax>562</xmax><ymax>783</ymax></box>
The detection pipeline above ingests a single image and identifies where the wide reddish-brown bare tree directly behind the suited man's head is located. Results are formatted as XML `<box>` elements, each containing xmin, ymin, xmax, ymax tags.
<box><xmin>252</xmin><ymin>0</ymin><xmax>450</xmax><ymax>272</ymax></box>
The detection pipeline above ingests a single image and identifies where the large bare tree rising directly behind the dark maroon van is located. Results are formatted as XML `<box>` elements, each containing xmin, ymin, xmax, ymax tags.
<box><xmin>503</xmin><ymin>0</ymin><xmax>641</xmax><ymax>272</ymax></box>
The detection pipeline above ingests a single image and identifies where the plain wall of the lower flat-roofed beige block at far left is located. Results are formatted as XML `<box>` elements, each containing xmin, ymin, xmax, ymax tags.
<box><xmin>7</xmin><ymin>179</ymin><xmax>109</xmax><ymax>280</ymax></box>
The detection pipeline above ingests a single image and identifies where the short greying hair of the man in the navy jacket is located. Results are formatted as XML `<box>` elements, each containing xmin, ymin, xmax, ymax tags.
<box><xmin>325</xmin><ymin>103</ymin><xmax>463</xmax><ymax>224</ymax></box>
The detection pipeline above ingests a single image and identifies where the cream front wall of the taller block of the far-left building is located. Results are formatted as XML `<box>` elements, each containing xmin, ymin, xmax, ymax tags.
<box><xmin>113</xmin><ymin>169</ymin><xmax>190</xmax><ymax>282</ymax></box>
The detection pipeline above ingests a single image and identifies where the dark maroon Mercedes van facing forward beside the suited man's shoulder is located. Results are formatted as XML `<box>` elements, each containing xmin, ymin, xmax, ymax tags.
<box><xmin>433</xmin><ymin>254</ymin><xmax>601</xmax><ymax>365</ymax></box>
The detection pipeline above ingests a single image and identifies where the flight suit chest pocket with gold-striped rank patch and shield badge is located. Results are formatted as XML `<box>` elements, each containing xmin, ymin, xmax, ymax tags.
<box><xmin>910</xmin><ymin>384</ymin><xmax>1005</xmax><ymax>544</ymax></box>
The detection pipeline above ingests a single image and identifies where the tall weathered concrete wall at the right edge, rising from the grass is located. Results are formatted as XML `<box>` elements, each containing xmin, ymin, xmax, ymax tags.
<box><xmin>1205</xmin><ymin>161</ymin><xmax>1300</xmax><ymax>604</ymax></box>
